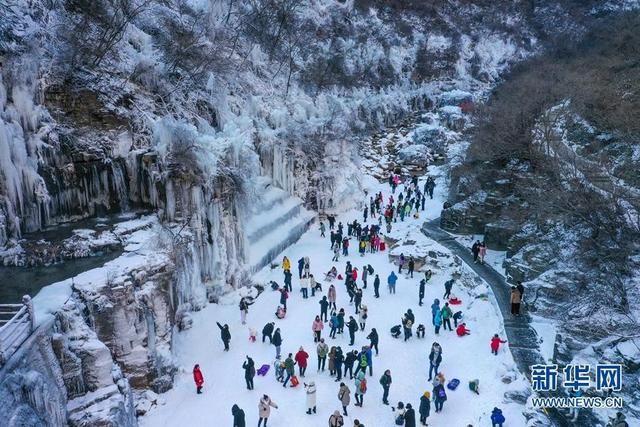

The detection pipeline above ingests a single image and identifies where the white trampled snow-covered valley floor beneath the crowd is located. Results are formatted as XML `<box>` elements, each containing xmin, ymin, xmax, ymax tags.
<box><xmin>140</xmin><ymin>176</ymin><xmax>528</xmax><ymax>427</ymax></box>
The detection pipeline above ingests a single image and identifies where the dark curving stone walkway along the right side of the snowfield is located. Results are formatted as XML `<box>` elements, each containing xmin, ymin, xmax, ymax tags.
<box><xmin>422</xmin><ymin>218</ymin><xmax>600</xmax><ymax>427</ymax></box>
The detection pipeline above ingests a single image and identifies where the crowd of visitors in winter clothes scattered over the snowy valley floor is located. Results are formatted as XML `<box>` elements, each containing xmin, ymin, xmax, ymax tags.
<box><xmin>193</xmin><ymin>175</ymin><xmax>510</xmax><ymax>427</ymax></box>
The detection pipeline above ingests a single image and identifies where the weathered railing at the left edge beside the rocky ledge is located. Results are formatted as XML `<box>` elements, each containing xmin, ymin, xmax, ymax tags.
<box><xmin>0</xmin><ymin>295</ymin><xmax>35</xmax><ymax>366</ymax></box>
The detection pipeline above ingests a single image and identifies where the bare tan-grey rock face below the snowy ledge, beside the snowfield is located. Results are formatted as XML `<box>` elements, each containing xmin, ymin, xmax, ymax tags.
<box><xmin>76</xmin><ymin>264</ymin><xmax>176</xmax><ymax>392</ymax></box>
